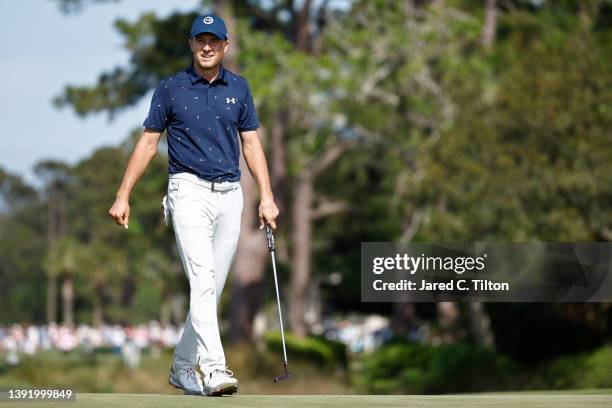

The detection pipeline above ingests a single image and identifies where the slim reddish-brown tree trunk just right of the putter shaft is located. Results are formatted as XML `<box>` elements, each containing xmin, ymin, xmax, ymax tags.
<box><xmin>290</xmin><ymin>171</ymin><xmax>314</xmax><ymax>337</ymax></box>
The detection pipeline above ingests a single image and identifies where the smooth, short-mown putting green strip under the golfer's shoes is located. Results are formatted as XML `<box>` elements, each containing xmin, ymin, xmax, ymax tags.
<box><xmin>0</xmin><ymin>390</ymin><xmax>612</xmax><ymax>408</ymax></box>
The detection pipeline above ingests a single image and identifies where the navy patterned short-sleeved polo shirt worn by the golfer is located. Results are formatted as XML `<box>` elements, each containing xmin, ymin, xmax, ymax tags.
<box><xmin>143</xmin><ymin>66</ymin><xmax>259</xmax><ymax>182</ymax></box>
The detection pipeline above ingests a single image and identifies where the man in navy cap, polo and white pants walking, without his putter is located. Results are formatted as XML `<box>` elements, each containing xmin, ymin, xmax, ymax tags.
<box><xmin>109</xmin><ymin>15</ymin><xmax>278</xmax><ymax>395</ymax></box>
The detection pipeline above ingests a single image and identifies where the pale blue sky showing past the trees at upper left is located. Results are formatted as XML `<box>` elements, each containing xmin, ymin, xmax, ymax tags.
<box><xmin>0</xmin><ymin>0</ymin><xmax>200</xmax><ymax>182</ymax></box>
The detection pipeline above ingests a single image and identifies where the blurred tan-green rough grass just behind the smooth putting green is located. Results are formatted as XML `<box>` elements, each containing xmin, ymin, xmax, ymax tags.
<box><xmin>0</xmin><ymin>347</ymin><xmax>357</xmax><ymax>396</ymax></box>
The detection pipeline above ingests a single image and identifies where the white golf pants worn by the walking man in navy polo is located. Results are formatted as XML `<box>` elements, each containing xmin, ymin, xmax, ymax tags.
<box><xmin>162</xmin><ymin>173</ymin><xmax>243</xmax><ymax>374</ymax></box>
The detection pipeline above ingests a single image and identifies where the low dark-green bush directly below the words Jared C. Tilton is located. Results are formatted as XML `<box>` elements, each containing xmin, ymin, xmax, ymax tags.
<box><xmin>355</xmin><ymin>342</ymin><xmax>516</xmax><ymax>394</ymax></box>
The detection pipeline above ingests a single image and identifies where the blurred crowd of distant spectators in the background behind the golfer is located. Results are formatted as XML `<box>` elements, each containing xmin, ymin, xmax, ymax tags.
<box><xmin>0</xmin><ymin>314</ymin><xmax>408</xmax><ymax>366</ymax></box>
